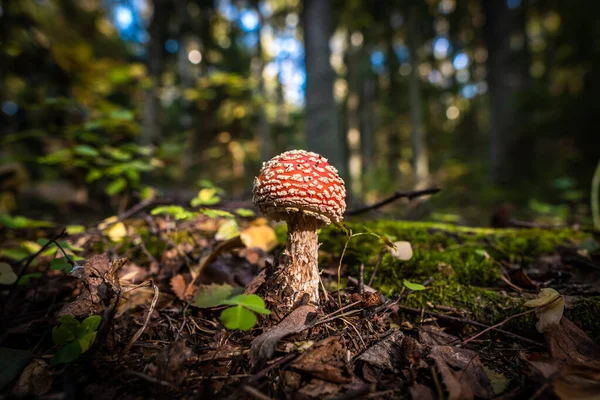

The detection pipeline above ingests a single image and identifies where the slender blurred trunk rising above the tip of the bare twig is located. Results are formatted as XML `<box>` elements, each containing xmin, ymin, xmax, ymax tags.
<box><xmin>407</xmin><ymin>5</ymin><xmax>429</xmax><ymax>187</ymax></box>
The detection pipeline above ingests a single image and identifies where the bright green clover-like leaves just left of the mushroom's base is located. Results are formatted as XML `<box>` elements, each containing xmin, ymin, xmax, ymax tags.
<box><xmin>192</xmin><ymin>284</ymin><xmax>271</xmax><ymax>331</ymax></box>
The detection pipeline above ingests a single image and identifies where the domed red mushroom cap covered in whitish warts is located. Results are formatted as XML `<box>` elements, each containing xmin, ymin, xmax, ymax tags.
<box><xmin>253</xmin><ymin>150</ymin><xmax>346</xmax><ymax>224</ymax></box>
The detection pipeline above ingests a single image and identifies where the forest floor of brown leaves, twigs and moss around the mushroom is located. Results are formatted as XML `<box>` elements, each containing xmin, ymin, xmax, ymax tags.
<box><xmin>0</xmin><ymin>207</ymin><xmax>600</xmax><ymax>399</ymax></box>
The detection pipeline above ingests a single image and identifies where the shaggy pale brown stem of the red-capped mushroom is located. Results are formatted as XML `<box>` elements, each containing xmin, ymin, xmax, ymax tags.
<box><xmin>280</xmin><ymin>213</ymin><xmax>322</xmax><ymax>307</ymax></box>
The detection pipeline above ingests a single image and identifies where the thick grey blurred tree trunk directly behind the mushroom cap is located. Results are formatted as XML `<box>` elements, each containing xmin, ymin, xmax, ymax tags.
<box><xmin>303</xmin><ymin>0</ymin><xmax>348</xmax><ymax>179</ymax></box>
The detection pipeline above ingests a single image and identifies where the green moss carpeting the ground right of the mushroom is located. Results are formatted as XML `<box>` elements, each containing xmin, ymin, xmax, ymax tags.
<box><xmin>319</xmin><ymin>221</ymin><xmax>600</xmax><ymax>336</ymax></box>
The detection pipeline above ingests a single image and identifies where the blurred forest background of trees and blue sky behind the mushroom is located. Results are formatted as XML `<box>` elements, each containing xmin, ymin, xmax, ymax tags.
<box><xmin>0</xmin><ymin>0</ymin><xmax>600</xmax><ymax>224</ymax></box>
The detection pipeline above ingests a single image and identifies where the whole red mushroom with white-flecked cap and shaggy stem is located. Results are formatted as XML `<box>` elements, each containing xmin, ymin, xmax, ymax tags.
<box><xmin>253</xmin><ymin>150</ymin><xmax>346</xmax><ymax>309</ymax></box>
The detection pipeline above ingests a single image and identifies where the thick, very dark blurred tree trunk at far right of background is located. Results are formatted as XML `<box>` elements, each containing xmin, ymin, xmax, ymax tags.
<box><xmin>482</xmin><ymin>0</ymin><xmax>529</xmax><ymax>186</ymax></box>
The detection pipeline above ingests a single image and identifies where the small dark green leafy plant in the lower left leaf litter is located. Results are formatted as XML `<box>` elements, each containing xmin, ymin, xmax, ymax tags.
<box><xmin>51</xmin><ymin>315</ymin><xmax>102</xmax><ymax>365</ymax></box>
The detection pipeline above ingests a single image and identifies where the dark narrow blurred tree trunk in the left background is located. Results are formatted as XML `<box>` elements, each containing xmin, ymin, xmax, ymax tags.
<box><xmin>141</xmin><ymin>0</ymin><xmax>170</xmax><ymax>144</ymax></box>
